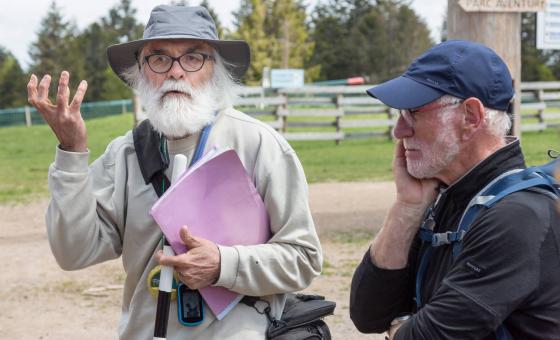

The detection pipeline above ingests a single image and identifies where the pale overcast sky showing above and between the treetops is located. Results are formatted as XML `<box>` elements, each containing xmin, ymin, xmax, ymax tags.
<box><xmin>0</xmin><ymin>0</ymin><xmax>447</xmax><ymax>68</ymax></box>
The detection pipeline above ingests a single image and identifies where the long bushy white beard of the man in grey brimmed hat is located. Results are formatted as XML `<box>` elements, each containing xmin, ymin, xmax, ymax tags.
<box><xmin>137</xmin><ymin>77</ymin><xmax>221</xmax><ymax>138</ymax></box>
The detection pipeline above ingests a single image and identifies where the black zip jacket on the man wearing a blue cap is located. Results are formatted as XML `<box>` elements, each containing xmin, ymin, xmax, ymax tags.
<box><xmin>350</xmin><ymin>141</ymin><xmax>560</xmax><ymax>340</ymax></box>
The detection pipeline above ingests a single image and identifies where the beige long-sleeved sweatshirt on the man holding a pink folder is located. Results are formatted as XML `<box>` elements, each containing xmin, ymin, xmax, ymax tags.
<box><xmin>46</xmin><ymin>109</ymin><xmax>322</xmax><ymax>339</ymax></box>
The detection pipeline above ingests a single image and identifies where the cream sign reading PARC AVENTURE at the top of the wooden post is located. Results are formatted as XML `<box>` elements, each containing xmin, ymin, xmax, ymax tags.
<box><xmin>459</xmin><ymin>0</ymin><xmax>547</xmax><ymax>12</ymax></box>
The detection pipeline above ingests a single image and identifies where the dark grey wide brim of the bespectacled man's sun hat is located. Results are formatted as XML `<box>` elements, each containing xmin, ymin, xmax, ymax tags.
<box><xmin>107</xmin><ymin>36</ymin><xmax>251</xmax><ymax>85</ymax></box>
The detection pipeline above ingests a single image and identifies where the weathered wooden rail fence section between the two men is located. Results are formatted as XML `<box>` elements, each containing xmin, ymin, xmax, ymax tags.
<box><xmin>235</xmin><ymin>86</ymin><xmax>397</xmax><ymax>142</ymax></box>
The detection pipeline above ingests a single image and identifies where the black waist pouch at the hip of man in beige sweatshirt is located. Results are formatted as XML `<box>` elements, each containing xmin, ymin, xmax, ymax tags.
<box><xmin>242</xmin><ymin>293</ymin><xmax>336</xmax><ymax>340</ymax></box>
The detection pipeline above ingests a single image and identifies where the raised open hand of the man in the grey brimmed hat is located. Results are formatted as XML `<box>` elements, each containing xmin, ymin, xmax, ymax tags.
<box><xmin>27</xmin><ymin>71</ymin><xmax>87</xmax><ymax>152</ymax></box>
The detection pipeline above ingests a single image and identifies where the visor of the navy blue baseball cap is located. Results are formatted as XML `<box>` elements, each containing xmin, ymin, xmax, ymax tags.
<box><xmin>366</xmin><ymin>76</ymin><xmax>445</xmax><ymax>109</ymax></box>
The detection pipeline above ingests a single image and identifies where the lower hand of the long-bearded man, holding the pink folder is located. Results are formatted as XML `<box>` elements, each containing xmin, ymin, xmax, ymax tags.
<box><xmin>156</xmin><ymin>226</ymin><xmax>220</xmax><ymax>289</ymax></box>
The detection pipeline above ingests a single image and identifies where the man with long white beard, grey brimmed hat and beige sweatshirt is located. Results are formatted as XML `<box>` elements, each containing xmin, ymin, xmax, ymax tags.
<box><xmin>28</xmin><ymin>6</ymin><xmax>322</xmax><ymax>339</ymax></box>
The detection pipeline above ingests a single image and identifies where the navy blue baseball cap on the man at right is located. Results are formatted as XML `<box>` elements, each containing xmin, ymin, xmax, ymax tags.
<box><xmin>367</xmin><ymin>40</ymin><xmax>514</xmax><ymax>111</ymax></box>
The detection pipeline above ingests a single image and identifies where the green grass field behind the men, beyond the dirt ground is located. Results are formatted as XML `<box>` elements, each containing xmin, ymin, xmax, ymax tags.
<box><xmin>0</xmin><ymin>114</ymin><xmax>560</xmax><ymax>203</ymax></box>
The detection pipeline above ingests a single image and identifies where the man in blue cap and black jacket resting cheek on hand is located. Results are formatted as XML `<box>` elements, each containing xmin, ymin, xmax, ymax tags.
<box><xmin>350</xmin><ymin>41</ymin><xmax>560</xmax><ymax>340</ymax></box>
